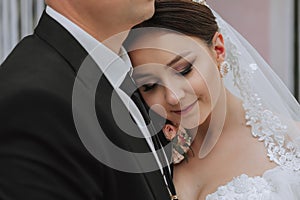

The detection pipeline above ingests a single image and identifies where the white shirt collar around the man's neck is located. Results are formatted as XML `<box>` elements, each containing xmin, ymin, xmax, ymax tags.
<box><xmin>46</xmin><ymin>6</ymin><xmax>132</xmax><ymax>88</ymax></box>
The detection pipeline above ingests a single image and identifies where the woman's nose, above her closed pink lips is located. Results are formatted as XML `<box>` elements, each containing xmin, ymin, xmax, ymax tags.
<box><xmin>165</xmin><ymin>85</ymin><xmax>184</xmax><ymax>105</ymax></box>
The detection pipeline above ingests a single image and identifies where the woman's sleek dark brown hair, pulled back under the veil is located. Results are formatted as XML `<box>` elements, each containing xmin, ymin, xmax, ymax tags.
<box><xmin>129</xmin><ymin>0</ymin><xmax>218</xmax><ymax>46</ymax></box>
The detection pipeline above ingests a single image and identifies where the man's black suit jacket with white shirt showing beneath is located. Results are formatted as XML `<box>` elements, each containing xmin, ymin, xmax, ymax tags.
<box><xmin>0</xmin><ymin>13</ymin><xmax>170</xmax><ymax>200</ymax></box>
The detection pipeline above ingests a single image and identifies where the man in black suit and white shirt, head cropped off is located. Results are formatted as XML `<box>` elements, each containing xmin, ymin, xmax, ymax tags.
<box><xmin>0</xmin><ymin>0</ymin><xmax>170</xmax><ymax>200</ymax></box>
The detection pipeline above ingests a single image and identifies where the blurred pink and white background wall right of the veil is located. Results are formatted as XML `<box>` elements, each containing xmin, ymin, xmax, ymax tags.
<box><xmin>207</xmin><ymin>0</ymin><xmax>299</xmax><ymax>98</ymax></box>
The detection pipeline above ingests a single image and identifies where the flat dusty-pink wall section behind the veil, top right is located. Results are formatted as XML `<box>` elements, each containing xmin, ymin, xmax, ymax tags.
<box><xmin>207</xmin><ymin>0</ymin><xmax>270</xmax><ymax>63</ymax></box>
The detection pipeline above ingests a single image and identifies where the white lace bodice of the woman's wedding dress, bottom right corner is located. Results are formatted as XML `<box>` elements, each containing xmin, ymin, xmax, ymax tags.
<box><xmin>206</xmin><ymin>126</ymin><xmax>300</xmax><ymax>200</ymax></box>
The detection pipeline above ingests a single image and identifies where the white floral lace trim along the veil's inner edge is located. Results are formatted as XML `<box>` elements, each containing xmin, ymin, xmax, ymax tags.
<box><xmin>217</xmin><ymin>10</ymin><xmax>300</xmax><ymax>171</ymax></box>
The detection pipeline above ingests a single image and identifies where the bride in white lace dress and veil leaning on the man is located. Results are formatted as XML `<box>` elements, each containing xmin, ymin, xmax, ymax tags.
<box><xmin>125</xmin><ymin>0</ymin><xmax>300</xmax><ymax>200</ymax></box>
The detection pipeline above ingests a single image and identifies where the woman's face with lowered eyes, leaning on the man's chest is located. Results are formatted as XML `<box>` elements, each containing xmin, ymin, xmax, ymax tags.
<box><xmin>129</xmin><ymin>32</ymin><xmax>221</xmax><ymax>128</ymax></box>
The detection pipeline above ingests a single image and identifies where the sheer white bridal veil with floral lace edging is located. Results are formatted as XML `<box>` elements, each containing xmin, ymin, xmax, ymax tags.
<box><xmin>211</xmin><ymin>4</ymin><xmax>300</xmax><ymax>169</ymax></box>
